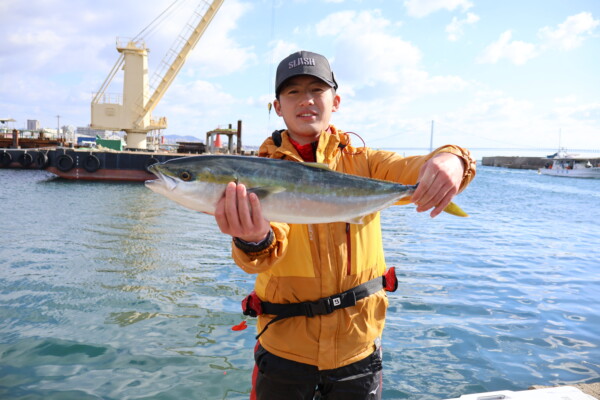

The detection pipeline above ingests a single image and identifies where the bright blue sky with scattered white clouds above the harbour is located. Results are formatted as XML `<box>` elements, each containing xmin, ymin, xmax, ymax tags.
<box><xmin>0</xmin><ymin>0</ymin><xmax>600</xmax><ymax>159</ymax></box>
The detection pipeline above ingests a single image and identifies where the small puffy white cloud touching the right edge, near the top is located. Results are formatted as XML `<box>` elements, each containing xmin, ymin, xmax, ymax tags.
<box><xmin>538</xmin><ymin>12</ymin><xmax>600</xmax><ymax>50</ymax></box>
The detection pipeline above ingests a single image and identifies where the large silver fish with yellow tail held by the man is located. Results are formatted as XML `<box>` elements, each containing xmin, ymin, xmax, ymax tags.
<box><xmin>146</xmin><ymin>155</ymin><xmax>467</xmax><ymax>224</ymax></box>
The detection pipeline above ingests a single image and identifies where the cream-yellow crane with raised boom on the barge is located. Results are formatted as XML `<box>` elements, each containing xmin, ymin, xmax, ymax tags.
<box><xmin>91</xmin><ymin>0</ymin><xmax>224</xmax><ymax>150</ymax></box>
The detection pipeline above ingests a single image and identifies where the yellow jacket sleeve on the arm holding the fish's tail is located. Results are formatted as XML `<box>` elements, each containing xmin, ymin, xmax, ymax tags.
<box><xmin>368</xmin><ymin>145</ymin><xmax>476</xmax><ymax>192</ymax></box>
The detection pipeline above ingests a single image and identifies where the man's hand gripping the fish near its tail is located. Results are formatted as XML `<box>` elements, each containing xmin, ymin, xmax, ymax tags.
<box><xmin>412</xmin><ymin>153</ymin><xmax>465</xmax><ymax>218</ymax></box>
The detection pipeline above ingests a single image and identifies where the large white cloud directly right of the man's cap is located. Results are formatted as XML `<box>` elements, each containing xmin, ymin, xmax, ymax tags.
<box><xmin>316</xmin><ymin>11</ymin><xmax>468</xmax><ymax>141</ymax></box>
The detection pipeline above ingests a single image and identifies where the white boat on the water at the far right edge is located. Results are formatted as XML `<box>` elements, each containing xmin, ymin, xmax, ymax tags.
<box><xmin>538</xmin><ymin>151</ymin><xmax>600</xmax><ymax>179</ymax></box>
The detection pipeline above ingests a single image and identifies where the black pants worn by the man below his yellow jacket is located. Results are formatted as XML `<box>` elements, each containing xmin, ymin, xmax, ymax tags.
<box><xmin>250</xmin><ymin>344</ymin><xmax>383</xmax><ymax>400</ymax></box>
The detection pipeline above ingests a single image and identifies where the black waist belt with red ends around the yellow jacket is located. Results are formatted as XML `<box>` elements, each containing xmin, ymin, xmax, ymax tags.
<box><xmin>242</xmin><ymin>267</ymin><xmax>398</xmax><ymax>339</ymax></box>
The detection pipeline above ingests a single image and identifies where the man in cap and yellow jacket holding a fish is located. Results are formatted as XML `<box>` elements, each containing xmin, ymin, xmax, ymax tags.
<box><xmin>215</xmin><ymin>51</ymin><xmax>475</xmax><ymax>400</ymax></box>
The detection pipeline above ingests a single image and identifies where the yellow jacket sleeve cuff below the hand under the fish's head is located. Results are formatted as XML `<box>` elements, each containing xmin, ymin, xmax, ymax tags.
<box><xmin>232</xmin><ymin>222</ymin><xmax>290</xmax><ymax>274</ymax></box>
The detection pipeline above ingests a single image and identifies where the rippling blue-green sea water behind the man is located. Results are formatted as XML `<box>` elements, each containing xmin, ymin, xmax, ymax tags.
<box><xmin>0</xmin><ymin>167</ymin><xmax>600</xmax><ymax>400</ymax></box>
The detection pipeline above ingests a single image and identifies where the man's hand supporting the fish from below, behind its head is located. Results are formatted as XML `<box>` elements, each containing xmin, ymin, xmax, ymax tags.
<box><xmin>215</xmin><ymin>182</ymin><xmax>271</xmax><ymax>242</ymax></box>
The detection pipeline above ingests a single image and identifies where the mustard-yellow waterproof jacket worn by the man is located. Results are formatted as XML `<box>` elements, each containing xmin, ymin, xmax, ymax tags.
<box><xmin>233</xmin><ymin>126</ymin><xmax>475</xmax><ymax>369</ymax></box>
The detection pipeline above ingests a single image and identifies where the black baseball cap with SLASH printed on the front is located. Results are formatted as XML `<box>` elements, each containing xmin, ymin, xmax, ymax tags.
<box><xmin>275</xmin><ymin>50</ymin><xmax>337</xmax><ymax>96</ymax></box>
